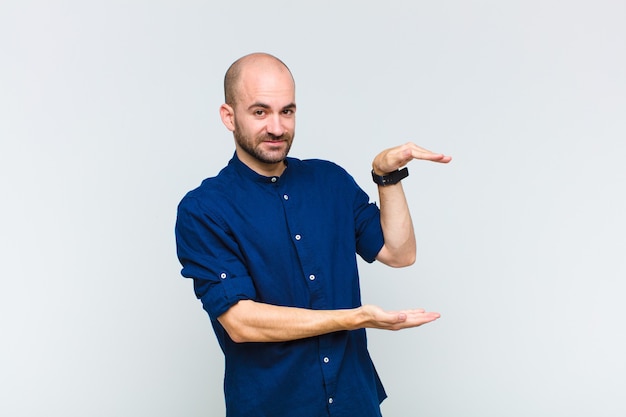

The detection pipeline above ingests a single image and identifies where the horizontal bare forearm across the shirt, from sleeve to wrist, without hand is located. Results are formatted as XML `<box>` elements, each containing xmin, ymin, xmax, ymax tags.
<box><xmin>218</xmin><ymin>300</ymin><xmax>359</xmax><ymax>342</ymax></box>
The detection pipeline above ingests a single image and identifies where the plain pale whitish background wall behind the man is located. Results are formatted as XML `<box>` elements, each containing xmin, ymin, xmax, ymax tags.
<box><xmin>0</xmin><ymin>0</ymin><xmax>626</xmax><ymax>417</ymax></box>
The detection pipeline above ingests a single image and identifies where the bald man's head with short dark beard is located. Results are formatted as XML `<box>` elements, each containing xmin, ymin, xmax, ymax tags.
<box><xmin>220</xmin><ymin>53</ymin><xmax>296</xmax><ymax>175</ymax></box>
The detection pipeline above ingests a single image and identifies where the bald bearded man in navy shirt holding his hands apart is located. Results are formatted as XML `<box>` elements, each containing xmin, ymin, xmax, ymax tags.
<box><xmin>176</xmin><ymin>53</ymin><xmax>451</xmax><ymax>417</ymax></box>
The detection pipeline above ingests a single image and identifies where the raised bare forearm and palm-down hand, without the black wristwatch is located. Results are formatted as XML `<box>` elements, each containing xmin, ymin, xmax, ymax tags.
<box><xmin>372</xmin><ymin>142</ymin><xmax>452</xmax><ymax>267</ymax></box>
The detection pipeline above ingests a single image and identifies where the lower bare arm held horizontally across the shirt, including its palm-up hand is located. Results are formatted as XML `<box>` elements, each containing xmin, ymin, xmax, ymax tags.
<box><xmin>218</xmin><ymin>300</ymin><xmax>439</xmax><ymax>343</ymax></box>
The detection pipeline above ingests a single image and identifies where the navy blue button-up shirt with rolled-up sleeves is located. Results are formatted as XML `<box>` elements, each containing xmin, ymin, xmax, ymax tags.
<box><xmin>176</xmin><ymin>155</ymin><xmax>386</xmax><ymax>417</ymax></box>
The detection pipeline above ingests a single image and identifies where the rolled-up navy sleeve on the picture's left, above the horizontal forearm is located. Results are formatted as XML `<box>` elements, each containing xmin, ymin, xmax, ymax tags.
<box><xmin>175</xmin><ymin>197</ymin><xmax>256</xmax><ymax>320</ymax></box>
